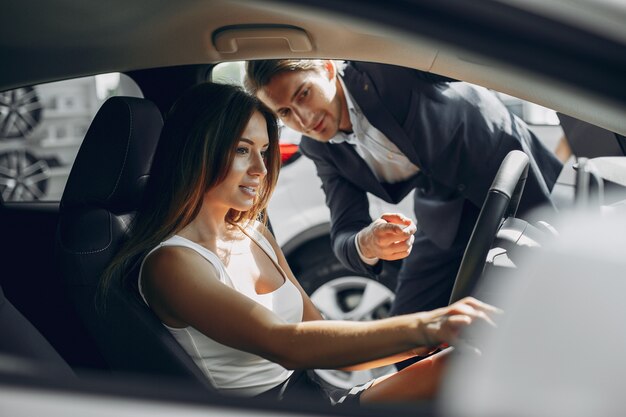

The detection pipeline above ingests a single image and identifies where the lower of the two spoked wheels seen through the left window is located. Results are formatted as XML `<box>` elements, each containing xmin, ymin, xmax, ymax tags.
<box><xmin>0</xmin><ymin>149</ymin><xmax>50</xmax><ymax>201</ymax></box>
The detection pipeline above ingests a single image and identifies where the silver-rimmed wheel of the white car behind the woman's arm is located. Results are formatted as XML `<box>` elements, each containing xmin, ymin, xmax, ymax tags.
<box><xmin>298</xmin><ymin>252</ymin><xmax>396</xmax><ymax>388</ymax></box>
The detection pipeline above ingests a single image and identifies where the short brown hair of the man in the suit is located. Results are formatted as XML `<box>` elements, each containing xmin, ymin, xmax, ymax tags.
<box><xmin>244</xmin><ymin>59</ymin><xmax>324</xmax><ymax>95</ymax></box>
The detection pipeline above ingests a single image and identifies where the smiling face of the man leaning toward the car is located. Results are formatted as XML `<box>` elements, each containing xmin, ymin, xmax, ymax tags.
<box><xmin>257</xmin><ymin>67</ymin><xmax>350</xmax><ymax>142</ymax></box>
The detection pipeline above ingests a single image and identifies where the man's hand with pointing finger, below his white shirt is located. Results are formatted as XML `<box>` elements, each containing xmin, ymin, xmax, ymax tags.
<box><xmin>357</xmin><ymin>213</ymin><xmax>417</xmax><ymax>261</ymax></box>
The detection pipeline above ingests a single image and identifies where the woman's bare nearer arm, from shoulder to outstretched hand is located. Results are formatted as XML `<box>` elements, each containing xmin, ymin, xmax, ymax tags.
<box><xmin>142</xmin><ymin>237</ymin><xmax>498</xmax><ymax>369</ymax></box>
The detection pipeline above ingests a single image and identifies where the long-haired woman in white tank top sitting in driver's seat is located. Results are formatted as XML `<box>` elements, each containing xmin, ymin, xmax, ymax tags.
<box><xmin>103</xmin><ymin>83</ymin><xmax>496</xmax><ymax>403</ymax></box>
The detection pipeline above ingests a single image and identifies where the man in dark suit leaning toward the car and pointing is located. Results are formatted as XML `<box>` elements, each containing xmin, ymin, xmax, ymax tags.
<box><xmin>246</xmin><ymin>60</ymin><xmax>561</xmax><ymax>315</ymax></box>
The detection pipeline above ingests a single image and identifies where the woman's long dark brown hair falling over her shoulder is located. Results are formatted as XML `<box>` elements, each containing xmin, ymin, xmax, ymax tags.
<box><xmin>100</xmin><ymin>83</ymin><xmax>280</xmax><ymax>303</ymax></box>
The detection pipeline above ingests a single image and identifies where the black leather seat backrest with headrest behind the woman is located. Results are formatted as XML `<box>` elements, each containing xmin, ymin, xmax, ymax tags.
<box><xmin>56</xmin><ymin>97</ymin><xmax>212</xmax><ymax>390</ymax></box>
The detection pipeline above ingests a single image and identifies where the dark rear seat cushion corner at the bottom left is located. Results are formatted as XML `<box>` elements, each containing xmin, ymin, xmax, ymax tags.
<box><xmin>0</xmin><ymin>287</ymin><xmax>75</xmax><ymax>378</ymax></box>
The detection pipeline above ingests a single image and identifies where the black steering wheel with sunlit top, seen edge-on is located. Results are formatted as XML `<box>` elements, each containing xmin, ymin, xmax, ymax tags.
<box><xmin>450</xmin><ymin>151</ymin><xmax>528</xmax><ymax>304</ymax></box>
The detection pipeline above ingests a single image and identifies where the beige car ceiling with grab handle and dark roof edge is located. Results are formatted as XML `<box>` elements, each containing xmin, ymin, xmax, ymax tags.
<box><xmin>0</xmin><ymin>0</ymin><xmax>626</xmax><ymax>134</ymax></box>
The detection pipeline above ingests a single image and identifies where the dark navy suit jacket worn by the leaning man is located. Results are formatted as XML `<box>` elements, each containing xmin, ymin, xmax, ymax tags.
<box><xmin>300</xmin><ymin>63</ymin><xmax>561</xmax><ymax>275</ymax></box>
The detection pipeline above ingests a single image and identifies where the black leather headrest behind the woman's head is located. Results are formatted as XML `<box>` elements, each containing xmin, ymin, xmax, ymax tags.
<box><xmin>61</xmin><ymin>97</ymin><xmax>163</xmax><ymax>213</ymax></box>
